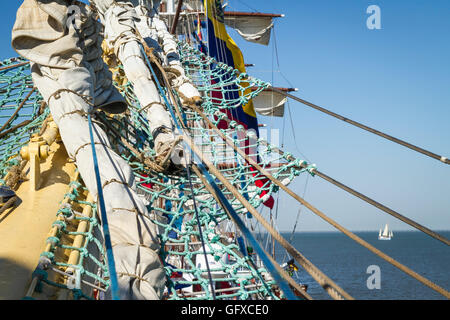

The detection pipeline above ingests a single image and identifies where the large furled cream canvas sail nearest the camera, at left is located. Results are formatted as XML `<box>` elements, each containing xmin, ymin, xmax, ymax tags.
<box><xmin>12</xmin><ymin>0</ymin><xmax>166</xmax><ymax>300</ymax></box>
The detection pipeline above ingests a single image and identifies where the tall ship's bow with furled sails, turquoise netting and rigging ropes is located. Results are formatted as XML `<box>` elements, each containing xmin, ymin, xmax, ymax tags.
<box><xmin>0</xmin><ymin>0</ymin><xmax>450</xmax><ymax>300</ymax></box>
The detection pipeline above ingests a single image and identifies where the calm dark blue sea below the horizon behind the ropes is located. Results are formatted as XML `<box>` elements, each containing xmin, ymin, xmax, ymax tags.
<box><xmin>270</xmin><ymin>231</ymin><xmax>450</xmax><ymax>300</ymax></box>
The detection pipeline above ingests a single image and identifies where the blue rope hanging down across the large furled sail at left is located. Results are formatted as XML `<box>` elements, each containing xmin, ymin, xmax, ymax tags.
<box><xmin>88</xmin><ymin>113</ymin><xmax>120</xmax><ymax>300</ymax></box>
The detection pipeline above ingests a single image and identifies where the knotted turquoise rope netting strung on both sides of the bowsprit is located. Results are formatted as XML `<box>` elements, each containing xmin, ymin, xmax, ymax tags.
<box><xmin>0</xmin><ymin>44</ymin><xmax>314</xmax><ymax>300</ymax></box>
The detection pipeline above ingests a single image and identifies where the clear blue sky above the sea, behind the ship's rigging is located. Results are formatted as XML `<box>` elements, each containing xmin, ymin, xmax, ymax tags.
<box><xmin>0</xmin><ymin>0</ymin><xmax>450</xmax><ymax>232</ymax></box>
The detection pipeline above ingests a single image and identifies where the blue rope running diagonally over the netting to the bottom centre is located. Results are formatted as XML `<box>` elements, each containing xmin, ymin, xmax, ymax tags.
<box><xmin>137</xmin><ymin>45</ymin><xmax>298</xmax><ymax>300</ymax></box>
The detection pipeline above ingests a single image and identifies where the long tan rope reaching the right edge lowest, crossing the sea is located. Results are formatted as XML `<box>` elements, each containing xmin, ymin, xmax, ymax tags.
<box><xmin>193</xmin><ymin>107</ymin><xmax>450</xmax><ymax>298</ymax></box>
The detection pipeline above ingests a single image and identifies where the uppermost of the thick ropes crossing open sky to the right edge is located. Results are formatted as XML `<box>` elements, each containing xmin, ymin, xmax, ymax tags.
<box><xmin>271</xmin><ymin>87</ymin><xmax>450</xmax><ymax>164</ymax></box>
